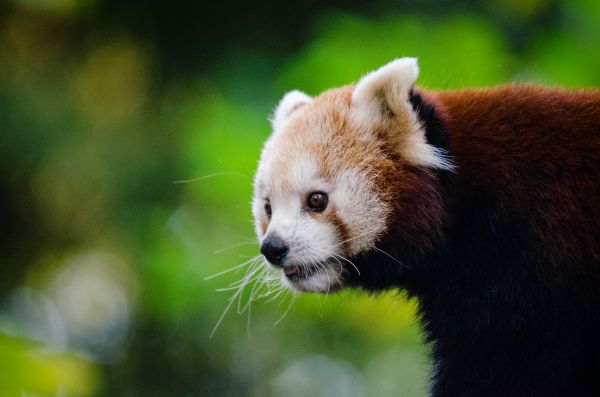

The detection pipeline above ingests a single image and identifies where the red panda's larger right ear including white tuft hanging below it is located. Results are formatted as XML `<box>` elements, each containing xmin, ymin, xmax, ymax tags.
<box><xmin>351</xmin><ymin>58</ymin><xmax>452</xmax><ymax>169</ymax></box>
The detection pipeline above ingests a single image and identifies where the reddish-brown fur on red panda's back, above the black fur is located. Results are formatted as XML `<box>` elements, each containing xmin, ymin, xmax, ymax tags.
<box><xmin>430</xmin><ymin>85</ymin><xmax>600</xmax><ymax>273</ymax></box>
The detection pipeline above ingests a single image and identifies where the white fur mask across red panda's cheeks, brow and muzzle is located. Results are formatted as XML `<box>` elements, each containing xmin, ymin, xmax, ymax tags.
<box><xmin>253</xmin><ymin>137</ymin><xmax>388</xmax><ymax>292</ymax></box>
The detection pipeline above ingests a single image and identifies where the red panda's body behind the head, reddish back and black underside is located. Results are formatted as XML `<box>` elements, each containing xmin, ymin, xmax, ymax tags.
<box><xmin>387</xmin><ymin>86</ymin><xmax>600</xmax><ymax>396</ymax></box>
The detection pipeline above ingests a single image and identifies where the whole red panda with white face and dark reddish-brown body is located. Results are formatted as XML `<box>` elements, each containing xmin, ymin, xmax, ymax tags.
<box><xmin>253</xmin><ymin>58</ymin><xmax>600</xmax><ymax>397</ymax></box>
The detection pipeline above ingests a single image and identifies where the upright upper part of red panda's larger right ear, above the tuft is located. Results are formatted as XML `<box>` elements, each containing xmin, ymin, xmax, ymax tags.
<box><xmin>352</xmin><ymin>58</ymin><xmax>419</xmax><ymax>124</ymax></box>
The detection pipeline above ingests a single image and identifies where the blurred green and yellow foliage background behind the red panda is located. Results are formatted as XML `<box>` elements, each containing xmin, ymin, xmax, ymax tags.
<box><xmin>0</xmin><ymin>0</ymin><xmax>600</xmax><ymax>397</ymax></box>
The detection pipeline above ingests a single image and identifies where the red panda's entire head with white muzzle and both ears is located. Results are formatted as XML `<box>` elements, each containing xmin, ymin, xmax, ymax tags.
<box><xmin>253</xmin><ymin>58</ymin><xmax>450</xmax><ymax>292</ymax></box>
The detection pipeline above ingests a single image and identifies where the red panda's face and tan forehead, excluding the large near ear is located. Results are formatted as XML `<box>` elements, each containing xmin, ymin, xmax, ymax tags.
<box><xmin>253</xmin><ymin>89</ymin><xmax>388</xmax><ymax>292</ymax></box>
